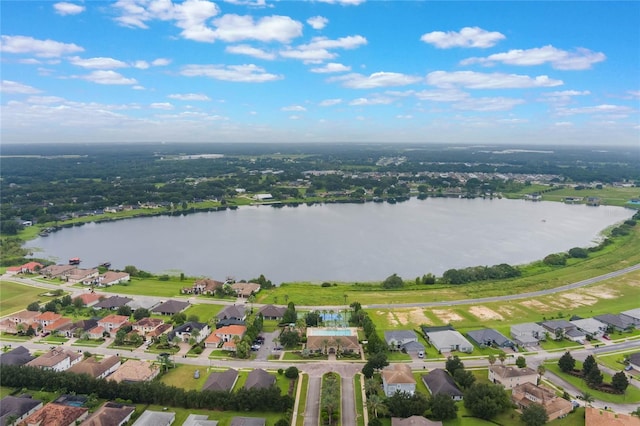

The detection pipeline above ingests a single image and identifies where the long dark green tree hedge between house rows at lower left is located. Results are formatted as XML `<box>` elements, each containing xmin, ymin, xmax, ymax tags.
<box><xmin>0</xmin><ymin>365</ymin><xmax>294</xmax><ymax>413</ymax></box>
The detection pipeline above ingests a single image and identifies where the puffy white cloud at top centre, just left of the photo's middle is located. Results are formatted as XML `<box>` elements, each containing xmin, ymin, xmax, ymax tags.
<box><xmin>213</xmin><ymin>14</ymin><xmax>302</xmax><ymax>43</ymax></box>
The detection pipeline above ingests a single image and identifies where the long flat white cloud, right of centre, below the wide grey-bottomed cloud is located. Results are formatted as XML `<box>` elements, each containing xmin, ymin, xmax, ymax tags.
<box><xmin>427</xmin><ymin>71</ymin><xmax>564</xmax><ymax>89</ymax></box>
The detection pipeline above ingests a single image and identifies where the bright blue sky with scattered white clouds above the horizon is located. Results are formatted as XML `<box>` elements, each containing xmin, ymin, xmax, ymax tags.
<box><xmin>0</xmin><ymin>0</ymin><xmax>640</xmax><ymax>146</ymax></box>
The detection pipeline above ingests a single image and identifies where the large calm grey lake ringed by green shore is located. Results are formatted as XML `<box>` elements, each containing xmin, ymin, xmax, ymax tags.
<box><xmin>26</xmin><ymin>198</ymin><xmax>635</xmax><ymax>284</ymax></box>
